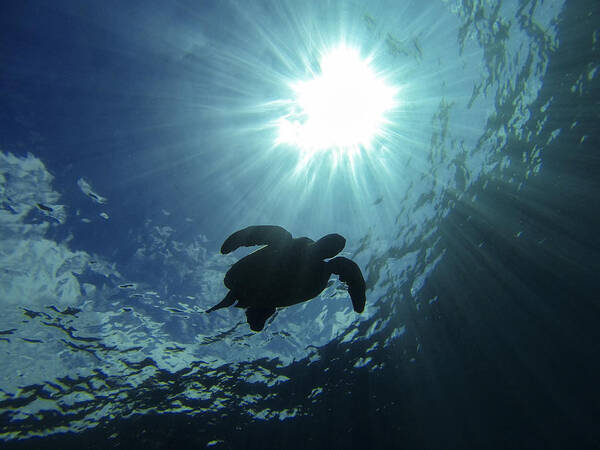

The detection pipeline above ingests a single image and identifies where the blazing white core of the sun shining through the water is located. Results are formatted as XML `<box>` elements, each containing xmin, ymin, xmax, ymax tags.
<box><xmin>278</xmin><ymin>47</ymin><xmax>397</xmax><ymax>153</ymax></box>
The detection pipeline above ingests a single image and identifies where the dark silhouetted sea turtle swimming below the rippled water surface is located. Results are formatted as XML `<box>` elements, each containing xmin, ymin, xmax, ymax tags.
<box><xmin>206</xmin><ymin>225</ymin><xmax>366</xmax><ymax>331</ymax></box>
